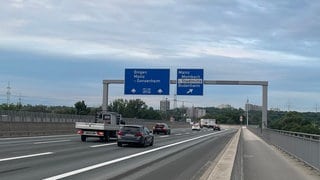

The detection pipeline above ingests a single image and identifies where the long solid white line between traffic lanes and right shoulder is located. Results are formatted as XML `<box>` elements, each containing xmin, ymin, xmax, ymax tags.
<box><xmin>44</xmin><ymin>133</ymin><xmax>222</xmax><ymax>180</ymax></box>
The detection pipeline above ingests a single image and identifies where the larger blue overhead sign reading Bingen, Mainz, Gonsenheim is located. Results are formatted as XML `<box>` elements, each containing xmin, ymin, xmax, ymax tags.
<box><xmin>124</xmin><ymin>69</ymin><xmax>170</xmax><ymax>95</ymax></box>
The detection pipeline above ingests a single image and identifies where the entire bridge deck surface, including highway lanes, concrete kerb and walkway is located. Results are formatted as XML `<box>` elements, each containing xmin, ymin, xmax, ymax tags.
<box><xmin>0</xmin><ymin>119</ymin><xmax>320</xmax><ymax>180</ymax></box>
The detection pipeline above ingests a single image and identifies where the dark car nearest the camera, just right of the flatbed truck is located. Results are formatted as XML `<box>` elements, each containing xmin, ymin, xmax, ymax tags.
<box><xmin>117</xmin><ymin>125</ymin><xmax>154</xmax><ymax>147</ymax></box>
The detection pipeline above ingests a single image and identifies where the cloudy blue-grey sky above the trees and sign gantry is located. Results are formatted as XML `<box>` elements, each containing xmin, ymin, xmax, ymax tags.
<box><xmin>0</xmin><ymin>0</ymin><xmax>320</xmax><ymax>112</ymax></box>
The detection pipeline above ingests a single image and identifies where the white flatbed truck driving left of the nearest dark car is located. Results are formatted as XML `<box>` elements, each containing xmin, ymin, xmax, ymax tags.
<box><xmin>75</xmin><ymin>112</ymin><xmax>125</xmax><ymax>142</ymax></box>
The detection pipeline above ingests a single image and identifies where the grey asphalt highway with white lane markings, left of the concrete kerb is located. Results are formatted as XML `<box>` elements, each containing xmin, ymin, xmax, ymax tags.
<box><xmin>0</xmin><ymin>128</ymin><xmax>235</xmax><ymax>180</ymax></box>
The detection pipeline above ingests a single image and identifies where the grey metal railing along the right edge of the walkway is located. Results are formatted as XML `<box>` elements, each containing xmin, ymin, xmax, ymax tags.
<box><xmin>249</xmin><ymin>127</ymin><xmax>320</xmax><ymax>171</ymax></box>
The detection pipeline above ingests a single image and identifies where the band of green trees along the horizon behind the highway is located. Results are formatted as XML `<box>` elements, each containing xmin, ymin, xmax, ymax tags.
<box><xmin>0</xmin><ymin>99</ymin><xmax>320</xmax><ymax>134</ymax></box>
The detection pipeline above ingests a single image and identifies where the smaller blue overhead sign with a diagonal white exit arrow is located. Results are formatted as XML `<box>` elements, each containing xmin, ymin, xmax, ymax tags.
<box><xmin>177</xmin><ymin>69</ymin><xmax>203</xmax><ymax>96</ymax></box>
